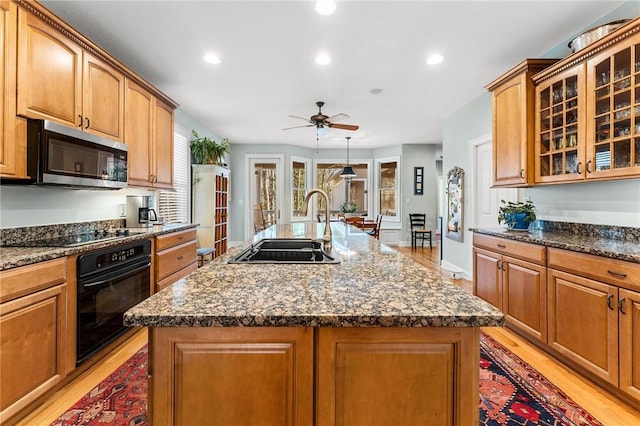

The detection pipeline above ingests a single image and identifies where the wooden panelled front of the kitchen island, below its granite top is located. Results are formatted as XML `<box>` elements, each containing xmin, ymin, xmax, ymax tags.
<box><xmin>150</xmin><ymin>327</ymin><xmax>479</xmax><ymax>426</ymax></box>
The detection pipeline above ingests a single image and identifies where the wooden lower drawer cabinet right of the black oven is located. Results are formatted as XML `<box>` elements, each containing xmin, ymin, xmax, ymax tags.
<box><xmin>152</xmin><ymin>229</ymin><xmax>198</xmax><ymax>293</ymax></box>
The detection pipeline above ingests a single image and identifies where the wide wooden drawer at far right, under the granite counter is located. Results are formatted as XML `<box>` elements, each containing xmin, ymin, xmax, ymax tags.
<box><xmin>548</xmin><ymin>247</ymin><xmax>640</xmax><ymax>290</ymax></box>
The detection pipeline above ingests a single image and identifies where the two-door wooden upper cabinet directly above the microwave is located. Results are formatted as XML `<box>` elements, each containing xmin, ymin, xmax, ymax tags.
<box><xmin>18</xmin><ymin>10</ymin><xmax>124</xmax><ymax>142</ymax></box>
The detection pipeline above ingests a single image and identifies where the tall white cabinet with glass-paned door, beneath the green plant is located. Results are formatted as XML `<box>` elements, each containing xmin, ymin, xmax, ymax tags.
<box><xmin>191</xmin><ymin>164</ymin><xmax>229</xmax><ymax>258</ymax></box>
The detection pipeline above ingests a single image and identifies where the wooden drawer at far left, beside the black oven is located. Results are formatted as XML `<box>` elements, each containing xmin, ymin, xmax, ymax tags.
<box><xmin>0</xmin><ymin>257</ymin><xmax>67</xmax><ymax>302</ymax></box>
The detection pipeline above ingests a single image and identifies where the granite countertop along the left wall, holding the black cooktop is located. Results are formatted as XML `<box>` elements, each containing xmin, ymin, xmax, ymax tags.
<box><xmin>0</xmin><ymin>224</ymin><xmax>197</xmax><ymax>270</ymax></box>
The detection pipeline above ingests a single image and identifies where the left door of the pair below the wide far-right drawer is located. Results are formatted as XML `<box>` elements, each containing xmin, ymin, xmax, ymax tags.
<box><xmin>548</xmin><ymin>269</ymin><xmax>618</xmax><ymax>386</ymax></box>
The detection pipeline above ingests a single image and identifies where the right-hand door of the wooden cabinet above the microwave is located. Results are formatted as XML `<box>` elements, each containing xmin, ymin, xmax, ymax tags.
<box><xmin>82</xmin><ymin>52</ymin><xmax>124</xmax><ymax>142</ymax></box>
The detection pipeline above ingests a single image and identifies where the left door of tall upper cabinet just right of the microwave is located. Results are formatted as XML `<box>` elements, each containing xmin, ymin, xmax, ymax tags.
<box><xmin>124</xmin><ymin>80</ymin><xmax>155</xmax><ymax>186</ymax></box>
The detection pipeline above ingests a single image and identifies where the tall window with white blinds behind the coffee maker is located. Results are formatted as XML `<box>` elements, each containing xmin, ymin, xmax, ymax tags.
<box><xmin>158</xmin><ymin>126</ymin><xmax>191</xmax><ymax>223</ymax></box>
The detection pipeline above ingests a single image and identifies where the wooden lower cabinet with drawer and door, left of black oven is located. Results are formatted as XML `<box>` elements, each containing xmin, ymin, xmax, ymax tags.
<box><xmin>0</xmin><ymin>258</ymin><xmax>67</xmax><ymax>424</ymax></box>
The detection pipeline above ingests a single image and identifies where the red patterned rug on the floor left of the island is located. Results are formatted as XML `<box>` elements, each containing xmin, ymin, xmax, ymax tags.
<box><xmin>51</xmin><ymin>345</ymin><xmax>148</xmax><ymax>426</ymax></box>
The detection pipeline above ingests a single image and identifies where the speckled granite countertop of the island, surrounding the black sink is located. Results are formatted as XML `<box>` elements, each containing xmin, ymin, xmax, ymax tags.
<box><xmin>124</xmin><ymin>223</ymin><xmax>504</xmax><ymax>327</ymax></box>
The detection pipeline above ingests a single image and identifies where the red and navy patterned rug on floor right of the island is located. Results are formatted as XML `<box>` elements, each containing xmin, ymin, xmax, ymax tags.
<box><xmin>480</xmin><ymin>333</ymin><xmax>602</xmax><ymax>426</ymax></box>
